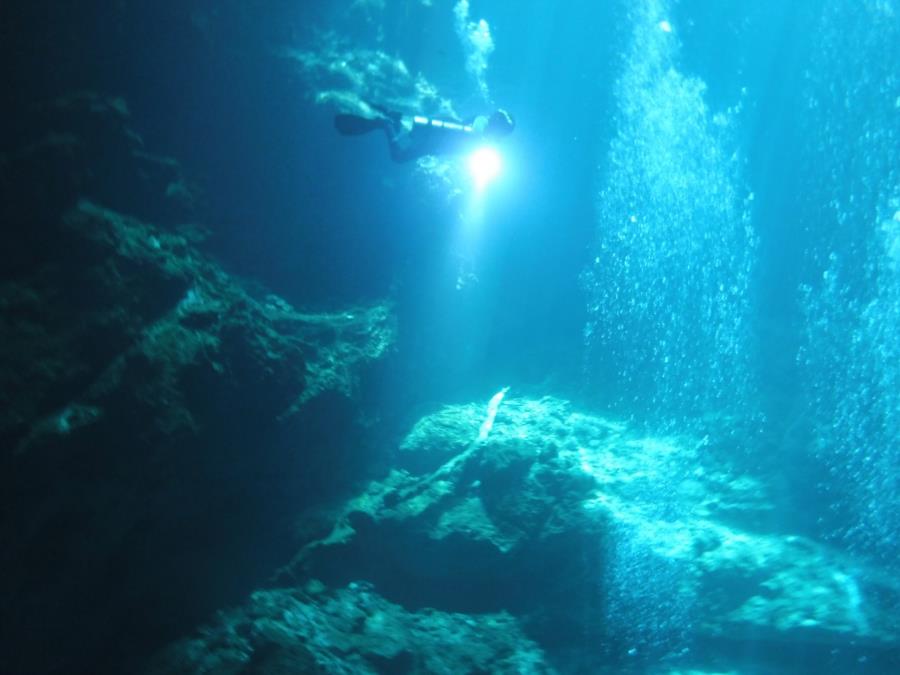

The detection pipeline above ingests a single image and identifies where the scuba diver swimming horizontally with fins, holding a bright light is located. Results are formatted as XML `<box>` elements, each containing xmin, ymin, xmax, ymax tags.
<box><xmin>334</xmin><ymin>105</ymin><xmax>516</xmax><ymax>162</ymax></box>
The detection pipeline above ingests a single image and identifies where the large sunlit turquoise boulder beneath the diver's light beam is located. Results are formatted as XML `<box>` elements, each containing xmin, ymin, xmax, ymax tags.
<box><xmin>281</xmin><ymin>398</ymin><xmax>900</xmax><ymax>672</ymax></box>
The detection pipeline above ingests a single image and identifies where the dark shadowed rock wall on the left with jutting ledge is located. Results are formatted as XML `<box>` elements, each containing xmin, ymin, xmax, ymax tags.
<box><xmin>0</xmin><ymin>93</ymin><xmax>395</xmax><ymax>673</ymax></box>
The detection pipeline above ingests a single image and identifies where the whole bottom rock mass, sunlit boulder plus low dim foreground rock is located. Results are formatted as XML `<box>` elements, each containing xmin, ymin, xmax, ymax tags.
<box><xmin>151</xmin><ymin>398</ymin><xmax>900</xmax><ymax>673</ymax></box>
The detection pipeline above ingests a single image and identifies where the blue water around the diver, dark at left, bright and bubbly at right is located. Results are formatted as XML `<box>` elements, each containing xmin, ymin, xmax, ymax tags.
<box><xmin>8</xmin><ymin>0</ymin><xmax>900</xmax><ymax>673</ymax></box>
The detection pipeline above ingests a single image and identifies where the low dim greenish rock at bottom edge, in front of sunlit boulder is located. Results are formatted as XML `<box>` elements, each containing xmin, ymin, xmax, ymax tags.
<box><xmin>147</xmin><ymin>582</ymin><xmax>552</xmax><ymax>675</ymax></box>
